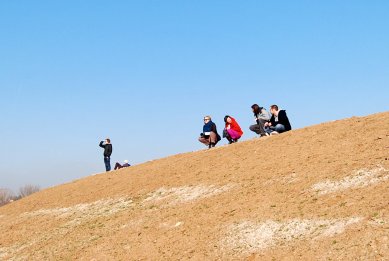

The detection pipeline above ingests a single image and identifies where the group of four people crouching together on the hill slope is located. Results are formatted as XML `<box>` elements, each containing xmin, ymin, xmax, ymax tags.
<box><xmin>199</xmin><ymin>104</ymin><xmax>292</xmax><ymax>148</ymax></box>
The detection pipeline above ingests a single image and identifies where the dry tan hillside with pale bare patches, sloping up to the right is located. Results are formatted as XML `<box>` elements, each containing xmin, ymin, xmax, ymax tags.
<box><xmin>0</xmin><ymin>112</ymin><xmax>389</xmax><ymax>260</ymax></box>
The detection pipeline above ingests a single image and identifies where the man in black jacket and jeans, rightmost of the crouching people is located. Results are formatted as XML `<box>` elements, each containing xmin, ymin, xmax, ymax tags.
<box><xmin>265</xmin><ymin>105</ymin><xmax>292</xmax><ymax>134</ymax></box>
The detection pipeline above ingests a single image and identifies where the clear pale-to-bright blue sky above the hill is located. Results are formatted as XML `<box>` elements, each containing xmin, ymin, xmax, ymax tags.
<box><xmin>0</xmin><ymin>0</ymin><xmax>389</xmax><ymax>192</ymax></box>
